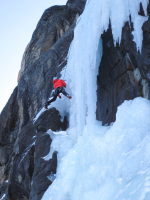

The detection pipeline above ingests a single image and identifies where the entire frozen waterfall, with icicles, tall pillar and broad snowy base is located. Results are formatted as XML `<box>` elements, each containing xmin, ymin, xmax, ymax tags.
<box><xmin>42</xmin><ymin>0</ymin><xmax>150</xmax><ymax>200</ymax></box>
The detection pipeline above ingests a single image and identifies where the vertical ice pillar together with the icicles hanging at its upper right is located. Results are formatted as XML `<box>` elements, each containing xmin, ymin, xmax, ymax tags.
<box><xmin>67</xmin><ymin>0</ymin><xmax>148</xmax><ymax>134</ymax></box>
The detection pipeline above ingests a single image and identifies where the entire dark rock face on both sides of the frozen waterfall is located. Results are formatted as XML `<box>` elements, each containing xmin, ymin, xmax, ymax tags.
<box><xmin>0</xmin><ymin>0</ymin><xmax>150</xmax><ymax>200</ymax></box>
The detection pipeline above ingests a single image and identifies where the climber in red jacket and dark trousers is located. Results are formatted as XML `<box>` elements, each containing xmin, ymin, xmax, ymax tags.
<box><xmin>45</xmin><ymin>77</ymin><xmax>72</xmax><ymax>109</ymax></box>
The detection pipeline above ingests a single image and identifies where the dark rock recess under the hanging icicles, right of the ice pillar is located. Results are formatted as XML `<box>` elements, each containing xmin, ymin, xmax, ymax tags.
<box><xmin>97</xmin><ymin>14</ymin><xmax>150</xmax><ymax>124</ymax></box>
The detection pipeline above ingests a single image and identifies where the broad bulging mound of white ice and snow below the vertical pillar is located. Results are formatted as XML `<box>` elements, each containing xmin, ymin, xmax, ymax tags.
<box><xmin>42</xmin><ymin>98</ymin><xmax>150</xmax><ymax>200</ymax></box>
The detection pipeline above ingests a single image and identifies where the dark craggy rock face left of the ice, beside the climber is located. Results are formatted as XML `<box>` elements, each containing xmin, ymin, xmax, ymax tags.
<box><xmin>0</xmin><ymin>0</ymin><xmax>85</xmax><ymax>200</ymax></box>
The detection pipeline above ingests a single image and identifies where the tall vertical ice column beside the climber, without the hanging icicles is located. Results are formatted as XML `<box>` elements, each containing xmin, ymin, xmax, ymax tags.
<box><xmin>67</xmin><ymin>0</ymin><xmax>102</xmax><ymax>134</ymax></box>
